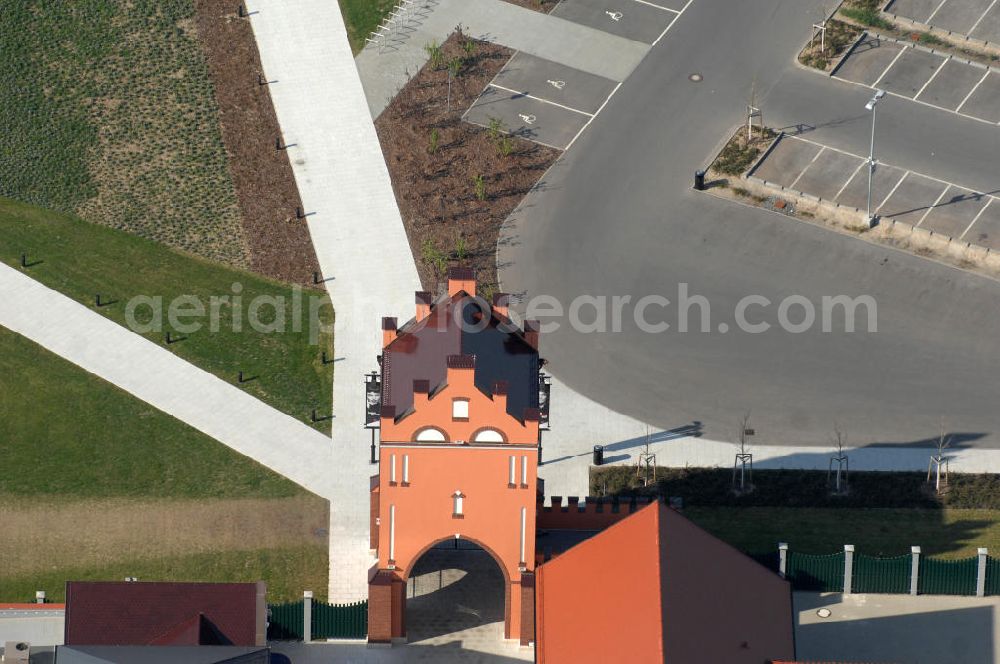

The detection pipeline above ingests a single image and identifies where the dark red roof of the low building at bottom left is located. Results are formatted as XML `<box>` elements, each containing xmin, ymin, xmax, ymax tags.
<box><xmin>65</xmin><ymin>581</ymin><xmax>266</xmax><ymax>646</ymax></box>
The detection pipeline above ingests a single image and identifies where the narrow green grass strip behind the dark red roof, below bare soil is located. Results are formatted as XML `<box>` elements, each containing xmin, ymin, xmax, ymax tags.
<box><xmin>0</xmin><ymin>542</ymin><xmax>329</xmax><ymax>603</ymax></box>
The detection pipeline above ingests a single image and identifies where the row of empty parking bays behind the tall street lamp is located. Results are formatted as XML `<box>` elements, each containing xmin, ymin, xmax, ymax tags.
<box><xmin>751</xmin><ymin>136</ymin><xmax>1000</xmax><ymax>251</ymax></box>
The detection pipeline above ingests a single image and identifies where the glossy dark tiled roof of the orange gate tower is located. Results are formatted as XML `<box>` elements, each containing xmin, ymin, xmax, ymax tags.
<box><xmin>382</xmin><ymin>293</ymin><xmax>539</xmax><ymax>420</ymax></box>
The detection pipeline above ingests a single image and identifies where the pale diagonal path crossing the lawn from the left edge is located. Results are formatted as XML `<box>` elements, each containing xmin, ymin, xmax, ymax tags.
<box><xmin>0</xmin><ymin>264</ymin><xmax>337</xmax><ymax>499</ymax></box>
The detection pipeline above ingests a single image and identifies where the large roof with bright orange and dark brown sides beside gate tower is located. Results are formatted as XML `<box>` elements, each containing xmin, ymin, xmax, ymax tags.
<box><xmin>536</xmin><ymin>503</ymin><xmax>794</xmax><ymax>664</ymax></box>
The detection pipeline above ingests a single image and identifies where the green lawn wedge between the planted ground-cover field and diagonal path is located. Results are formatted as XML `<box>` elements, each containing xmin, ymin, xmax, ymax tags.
<box><xmin>0</xmin><ymin>198</ymin><xmax>336</xmax><ymax>436</ymax></box>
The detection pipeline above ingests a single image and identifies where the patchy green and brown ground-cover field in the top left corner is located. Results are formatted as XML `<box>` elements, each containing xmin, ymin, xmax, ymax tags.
<box><xmin>0</xmin><ymin>0</ymin><xmax>249</xmax><ymax>267</ymax></box>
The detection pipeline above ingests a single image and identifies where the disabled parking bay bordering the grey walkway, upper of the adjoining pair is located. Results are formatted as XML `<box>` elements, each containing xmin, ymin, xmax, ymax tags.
<box><xmin>493</xmin><ymin>53</ymin><xmax>617</xmax><ymax>113</ymax></box>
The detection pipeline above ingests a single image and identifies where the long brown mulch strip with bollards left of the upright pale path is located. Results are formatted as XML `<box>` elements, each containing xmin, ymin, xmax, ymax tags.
<box><xmin>195</xmin><ymin>0</ymin><xmax>319</xmax><ymax>284</ymax></box>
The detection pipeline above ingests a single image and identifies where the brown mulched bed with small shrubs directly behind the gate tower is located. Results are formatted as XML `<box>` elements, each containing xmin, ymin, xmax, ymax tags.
<box><xmin>375</xmin><ymin>32</ymin><xmax>560</xmax><ymax>296</ymax></box>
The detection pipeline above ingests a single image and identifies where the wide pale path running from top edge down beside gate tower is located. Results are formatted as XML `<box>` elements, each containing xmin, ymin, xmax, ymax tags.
<box><xmin>247</xmin><ymin>0</ymin><xmax>420</xmax><ymax>602</ymax></box>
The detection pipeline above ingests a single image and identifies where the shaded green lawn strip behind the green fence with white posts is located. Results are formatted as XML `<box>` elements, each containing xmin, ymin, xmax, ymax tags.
<box><xmin>684</xmin><ymin>507</ymin><xmax>1000</xmax><ymax>558</ymax></box>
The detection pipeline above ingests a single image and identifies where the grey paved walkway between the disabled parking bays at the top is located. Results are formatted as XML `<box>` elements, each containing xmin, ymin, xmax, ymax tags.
<box><xmin>356</xmin><ymin>0</ymin><xmax>649</xmax><ymax>118</ymax></box>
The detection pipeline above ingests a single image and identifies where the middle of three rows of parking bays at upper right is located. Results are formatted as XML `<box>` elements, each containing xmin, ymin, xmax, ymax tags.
<box><xmin>833</xmin><ymin>32</ymin><xmax>1000</xmax><ymax>124</ymax></box>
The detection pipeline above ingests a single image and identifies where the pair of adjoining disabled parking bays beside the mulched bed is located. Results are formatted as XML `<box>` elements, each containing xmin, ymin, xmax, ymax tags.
<box><xmin>463</xmin><ymin>53</ymin><xmax>619</xmax><ymax>150</ymax></box>
